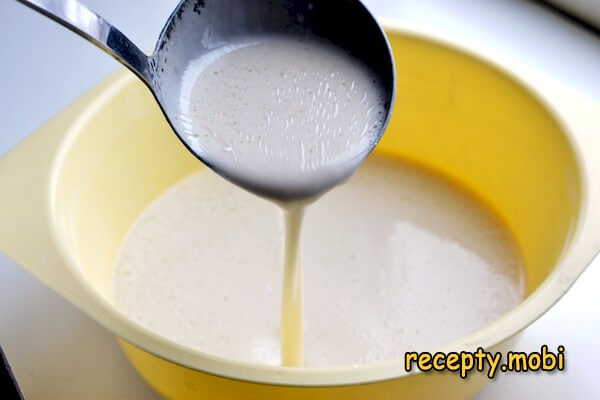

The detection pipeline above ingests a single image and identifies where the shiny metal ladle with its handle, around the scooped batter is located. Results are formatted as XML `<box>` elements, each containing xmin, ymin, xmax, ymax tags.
<box><xmin>17</xmin><ymin>0</ymin><xmax>395</xmax><ymax>200</ymax></box>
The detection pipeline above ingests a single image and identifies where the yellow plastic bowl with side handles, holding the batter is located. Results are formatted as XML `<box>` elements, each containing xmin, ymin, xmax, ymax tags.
<box><xmin>0</xmin><ymin>23</ymin><xmax>600</xmax><ymax>400</ymax></box>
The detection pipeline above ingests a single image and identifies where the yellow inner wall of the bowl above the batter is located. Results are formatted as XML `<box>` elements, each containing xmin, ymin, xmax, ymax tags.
<box><xmin>55</xmin><ymin>28</ymin><xmax>581</xmax><ymax>362</ymax></box>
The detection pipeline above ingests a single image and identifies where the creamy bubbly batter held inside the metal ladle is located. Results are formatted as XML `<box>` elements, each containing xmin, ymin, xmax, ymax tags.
<box><xmin>180</xmin><ymin>36</ymin><xmax>386</xmax><ymax>198</ymax></box>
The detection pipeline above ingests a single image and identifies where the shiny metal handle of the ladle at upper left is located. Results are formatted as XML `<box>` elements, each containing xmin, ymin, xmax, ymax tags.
<box><xmin>17</xmin><ymin>0</ymin><xmax>152</xmax><ymax>84</ymax></box>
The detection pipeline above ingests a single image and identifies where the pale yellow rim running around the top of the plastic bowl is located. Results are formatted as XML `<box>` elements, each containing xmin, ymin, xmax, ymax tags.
<box><xmin>48</xmin><ymin>19</ymin><xmax>595</xmax><ymax>387</ymax></box>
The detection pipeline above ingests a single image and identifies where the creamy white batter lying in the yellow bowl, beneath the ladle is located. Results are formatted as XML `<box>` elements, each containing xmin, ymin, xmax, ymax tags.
<box><xmin>113</xmin><ymin>156</ymin><xmax>524</xmax><ymax>367</ymax></box>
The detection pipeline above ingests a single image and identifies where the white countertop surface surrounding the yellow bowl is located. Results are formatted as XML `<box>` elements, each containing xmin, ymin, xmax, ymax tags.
<box><xmin>0</xmin><ymin>0</ymin><xmax>600</xmax><ymax>400</ymax></box>
